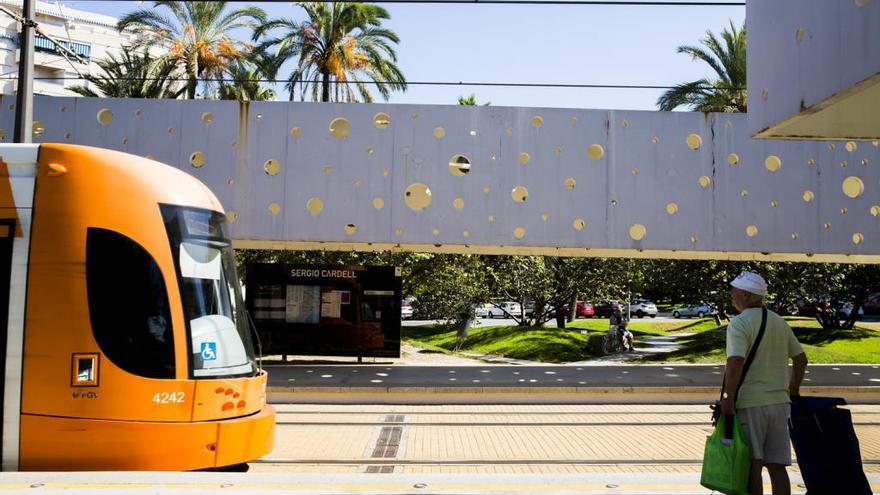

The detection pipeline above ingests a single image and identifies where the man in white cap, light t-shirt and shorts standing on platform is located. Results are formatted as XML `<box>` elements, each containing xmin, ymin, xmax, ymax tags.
<box><xmin>721</xmin><ymin>272</ymin><xmax>807</xmax><ymax>495</ymax></box>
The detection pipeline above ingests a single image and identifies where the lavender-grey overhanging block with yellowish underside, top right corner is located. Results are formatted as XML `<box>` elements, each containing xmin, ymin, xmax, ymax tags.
<box><xmin>746</xmin><ymin>0</ymin><xmax>880</xmax><ymax>140</ymax></box>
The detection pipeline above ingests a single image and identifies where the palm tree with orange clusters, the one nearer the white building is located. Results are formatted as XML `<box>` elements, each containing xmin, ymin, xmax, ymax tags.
<box><xmin>116</xmin><ymin>1</ymin><xmax>266</xmax><ymax>99</ymax></box>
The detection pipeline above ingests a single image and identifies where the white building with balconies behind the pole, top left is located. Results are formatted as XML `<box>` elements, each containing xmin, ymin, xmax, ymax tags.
<box><xmin>0</xmin><ymin>0</ymin><xmax>141</xmax><ymax>96</ymax></box>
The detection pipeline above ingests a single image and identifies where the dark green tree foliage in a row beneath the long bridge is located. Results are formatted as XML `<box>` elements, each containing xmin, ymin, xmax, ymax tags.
<box><xmin>239</xmin><ymin>251</ymin><xmax>880</xmax><ymax>330</ymax></box>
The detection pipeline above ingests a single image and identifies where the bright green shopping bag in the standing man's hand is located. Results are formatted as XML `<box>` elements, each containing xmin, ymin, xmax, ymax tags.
<box><xmin>700</xmin><ymin>414</ymin><xmax>752</xmax><ymax>495</ymax></box>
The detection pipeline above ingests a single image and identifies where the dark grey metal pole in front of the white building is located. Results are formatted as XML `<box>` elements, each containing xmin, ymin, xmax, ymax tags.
<box><xmin>14</xmin><ymin>0</ymin><xmax>34</xmax><ymax>143</ymax></box>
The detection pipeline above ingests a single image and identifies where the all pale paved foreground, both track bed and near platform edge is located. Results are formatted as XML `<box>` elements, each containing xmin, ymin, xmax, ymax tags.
<box><xmin>0</xmin><ymin>404</ymin><xmax>880</xmax><ymax>495</ymax></box>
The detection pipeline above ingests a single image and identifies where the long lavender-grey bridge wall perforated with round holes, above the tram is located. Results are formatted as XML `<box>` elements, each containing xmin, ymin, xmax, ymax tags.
<box><xmin>0</xmin><ymin>96</ymin><xmax>880</xmax><ymax>263</ymax></box>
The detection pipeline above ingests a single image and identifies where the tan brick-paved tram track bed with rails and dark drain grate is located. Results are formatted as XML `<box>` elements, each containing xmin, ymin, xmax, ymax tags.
<box><xmin>264</xmin><ymin>404</ymin><xmax>880</xmax><ymax>474</ymax></box>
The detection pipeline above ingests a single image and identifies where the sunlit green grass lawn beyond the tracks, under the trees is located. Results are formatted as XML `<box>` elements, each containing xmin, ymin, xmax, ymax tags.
<box><xmin>401</xmin><ymin>317</ymin><xmax>880</xmax><ymax>364</ymax></box>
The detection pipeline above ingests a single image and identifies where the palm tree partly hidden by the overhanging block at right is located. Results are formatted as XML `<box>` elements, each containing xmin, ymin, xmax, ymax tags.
<box><xmin>657</xmin><ymin>21</ymin><xmax>746</xmax><ymax>112</ymax></box>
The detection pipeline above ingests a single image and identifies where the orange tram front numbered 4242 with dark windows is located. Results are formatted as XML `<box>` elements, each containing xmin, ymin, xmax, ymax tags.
<box><xmin>0</xmin><ymin>144</ymin><xmax>275</xmax><ymax>471</ymax></box>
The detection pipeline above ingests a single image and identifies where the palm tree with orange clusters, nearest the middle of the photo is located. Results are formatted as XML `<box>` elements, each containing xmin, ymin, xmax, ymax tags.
<box><xmin>254</xmin><ymin>1</ymin><xmax>406</xmax><ymax>103</ymax></box>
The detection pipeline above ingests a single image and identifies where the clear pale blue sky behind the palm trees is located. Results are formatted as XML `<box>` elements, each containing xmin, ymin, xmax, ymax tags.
<box><xmin>63</xmin><ymin>0</ymin><xmax>745</xmax><ymax>110</ymax></box>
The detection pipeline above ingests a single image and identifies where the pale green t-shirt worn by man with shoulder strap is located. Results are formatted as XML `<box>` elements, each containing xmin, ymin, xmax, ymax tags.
<box><xmin>727</xmin><ymin>308</ymin><xmax>804</xmax><ymax>408</ymax></box>
